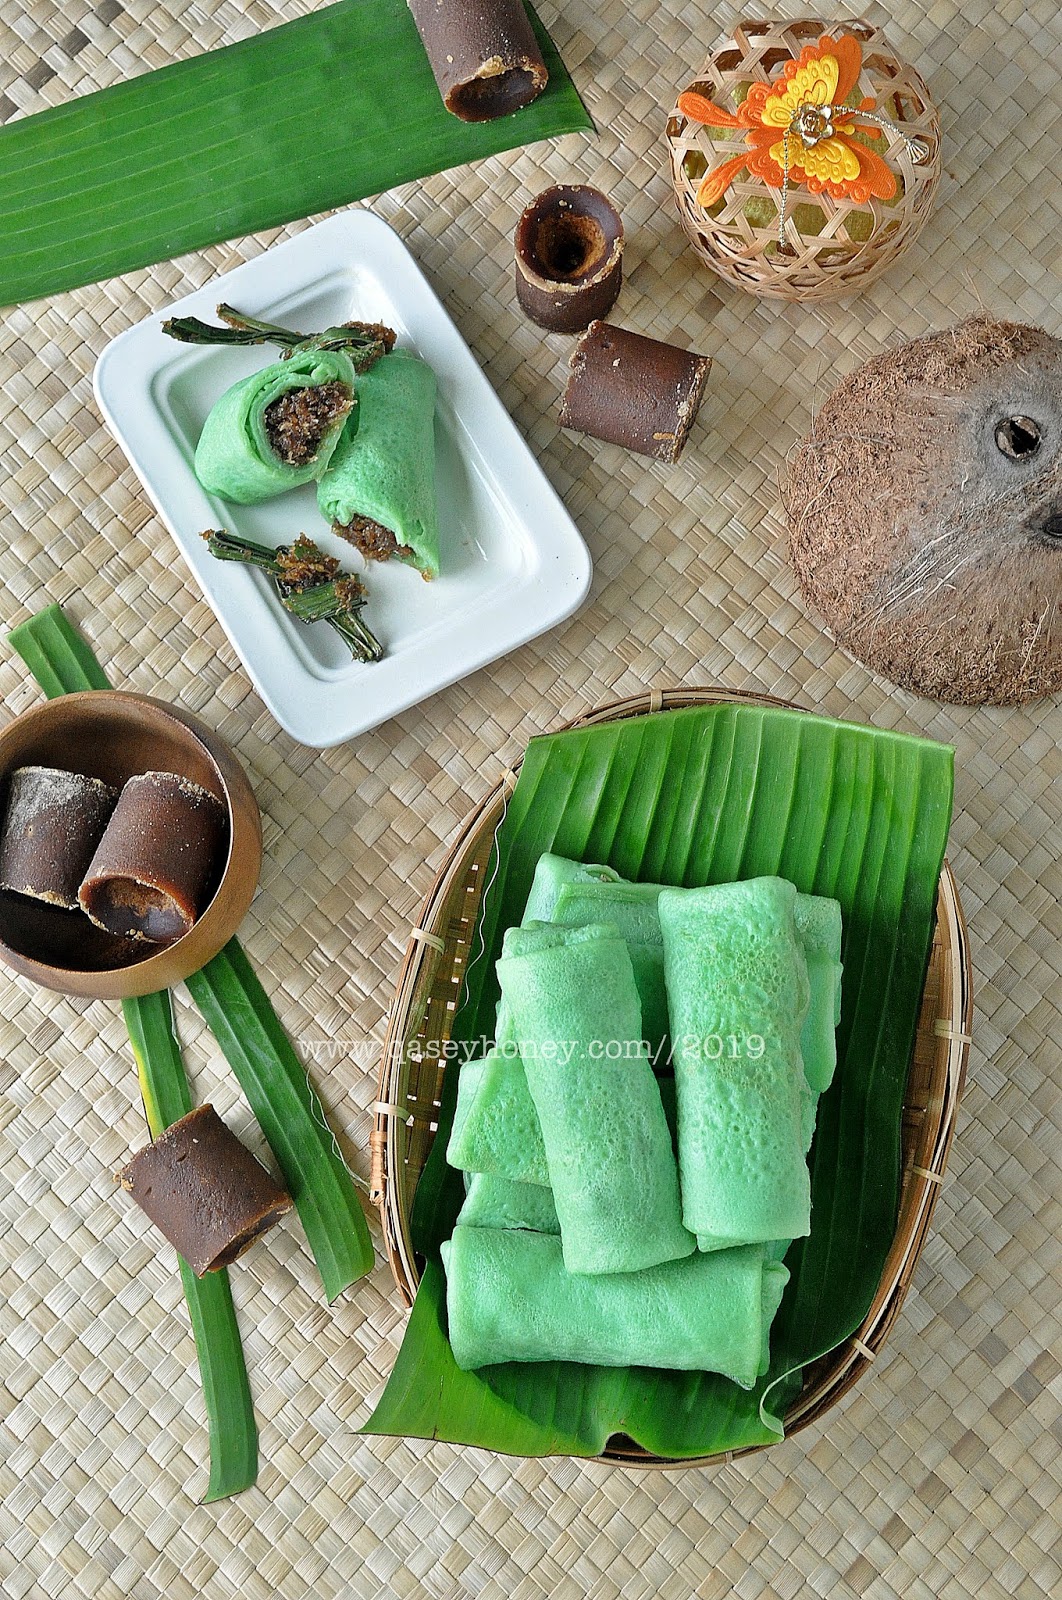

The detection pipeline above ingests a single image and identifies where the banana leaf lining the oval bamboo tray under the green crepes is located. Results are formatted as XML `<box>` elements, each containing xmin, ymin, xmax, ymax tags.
<box><xmin>363</xmin><ymin>704</ymin><xmax>953</xmax><ymax>1459</ymax></box>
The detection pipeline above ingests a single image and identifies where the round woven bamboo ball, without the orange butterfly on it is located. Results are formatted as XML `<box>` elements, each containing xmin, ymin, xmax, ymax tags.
<box><xmin>667</xmin><ymin>18</ymin><xmax>940</xmax><ymax>301</ymax></box>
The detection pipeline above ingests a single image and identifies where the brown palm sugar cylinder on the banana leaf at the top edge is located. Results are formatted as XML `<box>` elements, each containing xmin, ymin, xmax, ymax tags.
<box><xmin>408</xmin><ymin>0</ymin><xmax>549</xmax><ymax>122</ymax></box>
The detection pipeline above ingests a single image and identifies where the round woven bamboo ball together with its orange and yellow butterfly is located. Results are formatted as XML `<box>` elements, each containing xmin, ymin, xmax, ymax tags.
<box><xmin>667</xmin><ymin>18</ymin><xmax>940</xmax><ymax>301</ymax></box>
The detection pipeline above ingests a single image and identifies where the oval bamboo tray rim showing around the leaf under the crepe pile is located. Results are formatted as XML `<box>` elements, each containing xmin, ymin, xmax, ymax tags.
<box><xmin>369</xmin><ymin>688</ymin><xmax>972</xmax><ymax>1467</ymax></box>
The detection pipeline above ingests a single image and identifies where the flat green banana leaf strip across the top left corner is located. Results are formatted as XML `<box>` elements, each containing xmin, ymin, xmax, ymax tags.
<box><xmin>0</xmin><ymin>0</ymin><xmax>593</xmax><ymax>306</ymax></box>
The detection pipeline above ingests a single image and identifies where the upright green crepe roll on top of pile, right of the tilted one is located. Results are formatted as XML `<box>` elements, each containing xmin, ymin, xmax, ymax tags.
<box><xmin>655</xmin><ymin>878</ymin><xmax>811</xmax><ymax>1250</ymax></box>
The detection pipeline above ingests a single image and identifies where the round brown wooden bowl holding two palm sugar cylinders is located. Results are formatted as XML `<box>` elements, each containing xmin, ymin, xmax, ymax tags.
<box><xmin>0</xmin><ymin>690</ymin><xmax>262</xmax><ymax>1000</ymax></box>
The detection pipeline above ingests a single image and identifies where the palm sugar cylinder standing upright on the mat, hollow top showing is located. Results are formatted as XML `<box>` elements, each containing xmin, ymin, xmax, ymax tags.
<box><xmin>515</xmin><ymin>184</ymin><xmax>624</xmax><ymax>333</ymax></box>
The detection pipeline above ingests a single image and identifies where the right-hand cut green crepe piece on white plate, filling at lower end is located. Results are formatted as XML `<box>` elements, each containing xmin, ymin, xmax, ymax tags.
<box><xmin>317</xmin><ymin>350</ymin><xmax>438</xmax><ymax>578</ymax></box>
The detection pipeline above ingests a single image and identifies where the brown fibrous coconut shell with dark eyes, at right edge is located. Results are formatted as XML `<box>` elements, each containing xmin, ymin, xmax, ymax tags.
<box><xmin>784</xmin><ymin>317</ymin><xmax>1062</xmax><ymax>706</ymax></box>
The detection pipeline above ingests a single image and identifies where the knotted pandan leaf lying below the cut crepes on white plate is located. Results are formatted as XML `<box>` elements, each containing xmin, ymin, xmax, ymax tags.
<box><xmin>203</xmin><ymin>528</ymin><xmax>384</xmax><ymax>661</ymax></box>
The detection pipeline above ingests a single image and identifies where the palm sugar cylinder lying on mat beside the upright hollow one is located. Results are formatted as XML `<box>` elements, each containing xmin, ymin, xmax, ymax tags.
<box><xmin>560</xmin><ymin>322</ymin><xmax>712</xmax><ymax>464</ymax></box>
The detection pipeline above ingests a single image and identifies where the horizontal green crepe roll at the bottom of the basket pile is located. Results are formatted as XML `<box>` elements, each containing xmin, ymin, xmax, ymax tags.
<box><xmin>443</xmin><ymin>1227</ymin><xmax>789</xmax><ymax>1389</ymax></box>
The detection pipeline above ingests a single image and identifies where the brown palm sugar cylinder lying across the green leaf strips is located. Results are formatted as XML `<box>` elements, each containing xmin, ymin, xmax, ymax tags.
<box><xmin>118</xmin><ymin>1106</ymin><xmax>291</xmax><ymax>1278</ymax></box>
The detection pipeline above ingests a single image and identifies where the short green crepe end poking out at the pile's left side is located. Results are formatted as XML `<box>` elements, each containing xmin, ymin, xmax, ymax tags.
<box><xmin>446</xmin><ymin>1050</ymin><xmax>550</xmax><ymax>1187</ymax></box>
